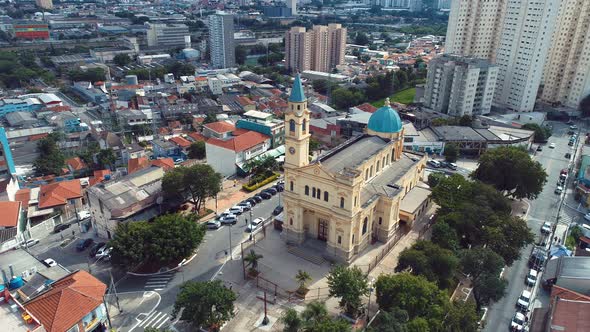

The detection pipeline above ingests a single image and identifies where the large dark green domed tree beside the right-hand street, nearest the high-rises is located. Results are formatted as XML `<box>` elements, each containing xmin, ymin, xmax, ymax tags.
<box><xmin>471</xmin><ymin>146</ymin><xmax>547</xmax><ymax>199</ymax></box>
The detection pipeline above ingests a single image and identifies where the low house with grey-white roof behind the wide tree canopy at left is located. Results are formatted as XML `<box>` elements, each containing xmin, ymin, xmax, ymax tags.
<box><xmin>86</xmin><ymin>167</ymin><xmax>164</xmax><ymax>239</ymax></box>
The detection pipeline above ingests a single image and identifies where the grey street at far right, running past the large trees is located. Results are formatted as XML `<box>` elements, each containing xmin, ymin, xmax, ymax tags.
<box><xmin>484</xmin><ymin>122</ymin><xmax>585</xmax><ymax>332</ymax></box>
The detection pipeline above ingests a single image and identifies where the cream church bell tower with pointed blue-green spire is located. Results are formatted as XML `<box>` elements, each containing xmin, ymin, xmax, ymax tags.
<box><xmin>285</xmin><ymin>74</ymin><xmax>310</xmax><ymax>168</ymax></box>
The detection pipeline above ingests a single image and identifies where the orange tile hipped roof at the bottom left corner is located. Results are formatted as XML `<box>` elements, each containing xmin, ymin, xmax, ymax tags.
<box><xmin>25</xmin><ymin>271</ymin><xmax>107</xmax><ymax>332</ymax></box>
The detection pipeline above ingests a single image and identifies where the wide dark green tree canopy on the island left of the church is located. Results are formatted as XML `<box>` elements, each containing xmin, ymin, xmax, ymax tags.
<box><xmin>109</xmin><ymin>214</ymin><xmax>205</xmax><ymax>267</ymax></box>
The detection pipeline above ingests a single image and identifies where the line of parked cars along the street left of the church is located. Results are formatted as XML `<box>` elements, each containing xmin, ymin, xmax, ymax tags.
<box><xmin>207</xmin><ymin>181</ymin><xmax>285</xmax><ymax>232</ymax></box>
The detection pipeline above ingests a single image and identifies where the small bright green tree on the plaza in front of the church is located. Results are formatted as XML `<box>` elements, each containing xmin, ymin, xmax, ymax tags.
<box><xmin>328</xmin><ymin>265</ymin><xmax>369</xmax><ymax>317</ymax></box>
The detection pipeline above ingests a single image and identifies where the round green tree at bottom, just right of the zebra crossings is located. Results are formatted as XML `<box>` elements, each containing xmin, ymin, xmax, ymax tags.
<box><xmin>172</xmin><ymin>280</ymin><xmax>237</xmax><ymax>331</ymax></box>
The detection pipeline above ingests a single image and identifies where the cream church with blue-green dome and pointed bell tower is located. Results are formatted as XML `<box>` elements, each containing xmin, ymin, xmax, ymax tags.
<box><xmin>283</xmin><ymin>75</ymin><xmax>429</xmax><ymax>263</ymax></box>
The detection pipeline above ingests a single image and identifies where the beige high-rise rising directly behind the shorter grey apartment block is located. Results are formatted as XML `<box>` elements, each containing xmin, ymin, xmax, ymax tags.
<box><xmin>445</xmin><ymin>0</ymin><xmax>507</xmax><ymax>62</ymax></box>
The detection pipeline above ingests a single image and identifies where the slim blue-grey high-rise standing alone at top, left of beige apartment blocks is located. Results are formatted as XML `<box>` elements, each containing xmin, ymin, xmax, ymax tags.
<box><xmin>209</xmin><ymin>12</ymin><xmax>236</xmax><ymax>68</ymax></box>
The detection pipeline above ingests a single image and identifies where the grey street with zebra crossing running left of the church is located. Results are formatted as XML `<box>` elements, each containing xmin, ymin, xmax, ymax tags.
<box><xmin>117</xmin><ymin>188</ymin><xmax>279</xmax><ymax>332</ymax></box>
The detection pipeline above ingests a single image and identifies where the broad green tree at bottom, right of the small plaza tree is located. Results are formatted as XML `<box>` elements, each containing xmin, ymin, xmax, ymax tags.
<box><xmin>376</xmin><ymin>273</ymin><xmax>449</xmax><ymax>330</ymax></box>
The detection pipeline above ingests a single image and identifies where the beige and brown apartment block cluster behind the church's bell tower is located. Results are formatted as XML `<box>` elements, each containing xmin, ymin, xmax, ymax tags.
<box><xmin>285</xmin><ymin>23</ymin><xmax>346</xmax><ymax>72</ymax></box>
